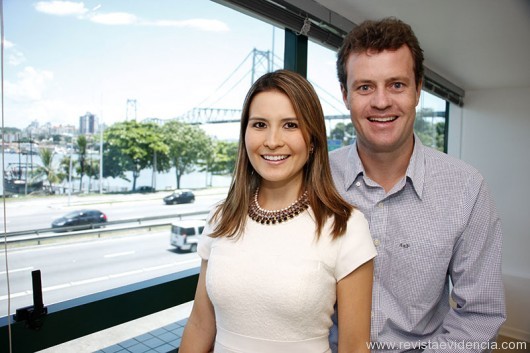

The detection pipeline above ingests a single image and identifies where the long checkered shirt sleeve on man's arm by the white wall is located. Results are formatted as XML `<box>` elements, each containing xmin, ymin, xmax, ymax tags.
<box><xmin>425</xmin><ymin>176</ymin><xmax>506</xmax><ymax>353</ymax></box>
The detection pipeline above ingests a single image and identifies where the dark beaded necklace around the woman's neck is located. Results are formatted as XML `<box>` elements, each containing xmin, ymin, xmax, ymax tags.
<box><xmin>248</xmin><ymin>187</ymin><xmax>309</xmax><ymax>225</ymax></box>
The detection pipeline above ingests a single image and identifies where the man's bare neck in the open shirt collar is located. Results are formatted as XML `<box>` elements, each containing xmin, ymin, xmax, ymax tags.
<box><xmin>357</xmin><ymin>139</ymin><xmax>414</xmax><ymax>192</ymax></box>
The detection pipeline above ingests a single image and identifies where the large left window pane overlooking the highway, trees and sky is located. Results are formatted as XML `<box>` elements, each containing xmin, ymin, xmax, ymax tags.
<box><xmin>0</xmin><ymin>0</ymin><xmax>284</xmax><ymax>316</ymax></box>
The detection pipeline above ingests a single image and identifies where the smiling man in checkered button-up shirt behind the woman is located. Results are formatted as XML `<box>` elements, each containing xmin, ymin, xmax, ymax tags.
<box><xmin>330</xmin><ymin>18</ymin><xmax>506</xmax><ymax>352</ymax></box>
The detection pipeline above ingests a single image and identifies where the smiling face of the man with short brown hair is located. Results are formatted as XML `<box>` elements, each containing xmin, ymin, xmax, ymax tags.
<box><xmin>342</xmin><ymin>46</ymin><xmax>421</xmax><ymax>153</ymax></box>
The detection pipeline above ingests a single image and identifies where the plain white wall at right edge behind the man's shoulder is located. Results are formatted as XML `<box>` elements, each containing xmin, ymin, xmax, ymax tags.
<box><xmin>448</xmin><ymin>87</ymin><xmax>530</xmax><ymax>341</ymax></box>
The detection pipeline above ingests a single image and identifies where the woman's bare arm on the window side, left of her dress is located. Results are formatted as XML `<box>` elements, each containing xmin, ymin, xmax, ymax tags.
<box><xmin>179</xmin><ymin>260</ymin><xmax>216</xmax><ymax>353</ymax></box>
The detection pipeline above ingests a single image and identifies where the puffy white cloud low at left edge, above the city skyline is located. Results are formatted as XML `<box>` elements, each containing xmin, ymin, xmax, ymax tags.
<box><xmin>4</xmin><ymin>66</ymin><xmax>53</xmax><ymax>101</ymax></box>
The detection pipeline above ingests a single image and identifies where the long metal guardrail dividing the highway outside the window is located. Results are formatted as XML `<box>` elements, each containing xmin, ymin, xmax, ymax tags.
<box><xmin>0</xmin><ymin>211</ymin><xmax>209</xmax><ymax>244</ymax></box>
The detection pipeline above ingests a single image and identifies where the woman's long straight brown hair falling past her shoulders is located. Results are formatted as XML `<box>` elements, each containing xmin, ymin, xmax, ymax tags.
<box><xmin>210</xmin><ymin>70</ymin><xmax>353</xmax><ymax>238</ymax></box>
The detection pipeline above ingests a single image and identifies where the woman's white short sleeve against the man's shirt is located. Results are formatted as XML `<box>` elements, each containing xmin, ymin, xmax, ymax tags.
<box><xmin>335</xmin><ymin>209</ymin><xmax>377</xmax><ymax>282</ymax></box>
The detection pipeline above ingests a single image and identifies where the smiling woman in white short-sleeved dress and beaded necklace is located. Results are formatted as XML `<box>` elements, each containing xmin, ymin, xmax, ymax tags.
<box><xmin>179</xmin><ymin>70</ymin><xmax>375</xmax><ymax>353</ymax></box>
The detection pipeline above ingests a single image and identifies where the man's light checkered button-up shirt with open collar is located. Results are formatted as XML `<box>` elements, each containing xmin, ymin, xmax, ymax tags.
<box><xmin>330</xmin><ymin>136</ymin><xmax>506</xmax><ymax>352</ymax></box>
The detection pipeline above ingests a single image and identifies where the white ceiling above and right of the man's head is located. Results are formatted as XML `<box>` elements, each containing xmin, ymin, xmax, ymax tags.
<box><xmin>316</xmin><ymin>0</ymin><xmax>530</xmax><ymax>92</ymax></box>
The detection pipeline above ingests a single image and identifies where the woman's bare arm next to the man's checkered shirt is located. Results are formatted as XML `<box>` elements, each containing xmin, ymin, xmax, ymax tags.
<box><xmin>337</xmin><ymin>260</ymin><xmax>374</xmax><ymax>353</ymax></box>
